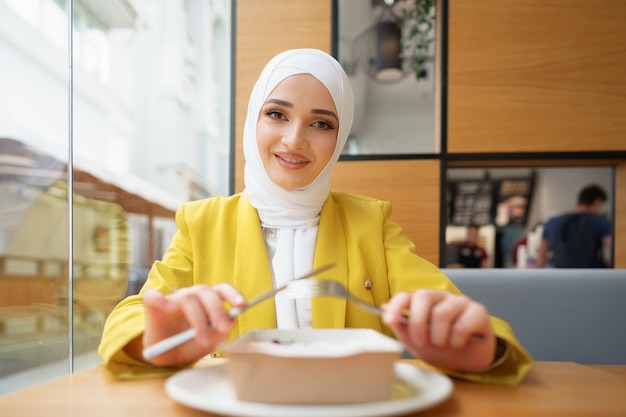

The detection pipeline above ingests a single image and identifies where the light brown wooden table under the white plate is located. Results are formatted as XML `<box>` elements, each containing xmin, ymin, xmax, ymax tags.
<box><xmin>0</xmin><ymin>360</ymin><xmax>626</xmax><ymax>417</ymax></box>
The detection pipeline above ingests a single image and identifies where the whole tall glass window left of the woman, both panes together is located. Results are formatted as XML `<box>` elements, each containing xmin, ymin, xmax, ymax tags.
<box><xmin>0</xmin><ymin>0</ymin><xmax>230</xmax><ymax>395</ymax></box>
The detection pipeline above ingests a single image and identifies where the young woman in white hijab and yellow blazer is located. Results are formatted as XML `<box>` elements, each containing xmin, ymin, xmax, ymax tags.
<box><xmin>99</xmin><ymin>49</ymin><xmax>531</xmax><ymax>383</ymax></box>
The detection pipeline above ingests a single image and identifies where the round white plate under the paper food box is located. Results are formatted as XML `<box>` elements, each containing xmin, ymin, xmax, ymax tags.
<box><xmin>165</xmin><ymin>362</ymin><xmax>453</xmax><ymax>417</ymax></box>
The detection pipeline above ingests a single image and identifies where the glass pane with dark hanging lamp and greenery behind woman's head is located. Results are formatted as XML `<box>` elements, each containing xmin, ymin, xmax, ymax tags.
<box><xmin>333</xmin><ymin>0</ymin><xmax>440</xmax><ymax>155</ymax></box>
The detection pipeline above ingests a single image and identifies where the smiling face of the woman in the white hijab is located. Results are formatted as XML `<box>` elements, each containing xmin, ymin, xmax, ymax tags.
<box><xmin>256</xmin><ymin>74</ymin><xmax>339</xmax><ymax>190</ymax></box>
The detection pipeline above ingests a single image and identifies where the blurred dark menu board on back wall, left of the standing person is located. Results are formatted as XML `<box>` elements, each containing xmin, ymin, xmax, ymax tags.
<box><xmin>447</xmin><ymin>178</ymin><xmax>534</xmax><ymax>227</ymax></box>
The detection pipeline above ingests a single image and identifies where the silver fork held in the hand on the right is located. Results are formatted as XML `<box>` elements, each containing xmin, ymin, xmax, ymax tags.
<box><xmin>283</xmin><ymin>279</ymin><xmax>485</xmax><ymax>342</ymax></box>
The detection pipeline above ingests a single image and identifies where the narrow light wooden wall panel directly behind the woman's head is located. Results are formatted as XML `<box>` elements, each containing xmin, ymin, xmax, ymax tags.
<box><xmin>234</xmin><ymin>0</ymin><xmax>332</xmax><ymax>191</ymax></box>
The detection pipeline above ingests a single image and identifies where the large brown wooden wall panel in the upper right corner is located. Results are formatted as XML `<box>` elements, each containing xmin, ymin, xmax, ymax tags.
<box><xmin>448</xmin><ymin>0</ymin><xmax>626</xmax><ymax>152</ymax></box>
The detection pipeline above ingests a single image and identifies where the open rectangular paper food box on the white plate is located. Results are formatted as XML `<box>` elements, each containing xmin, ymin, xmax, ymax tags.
<box><xmin>227</xmin><ymin>329</ymin><xmax>402</xmax><ymax>404</ymax></box>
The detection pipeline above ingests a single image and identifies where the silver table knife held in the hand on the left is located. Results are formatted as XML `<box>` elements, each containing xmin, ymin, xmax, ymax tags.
<box><xmin>142</xmin><ymin>264</ymin><xmax>335</xmax><ymax>360</ymax></box>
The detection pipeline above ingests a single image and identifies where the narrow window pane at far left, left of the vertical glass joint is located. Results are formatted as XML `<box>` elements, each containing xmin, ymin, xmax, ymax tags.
<box><xmin>0</xmin><ymin>0</ymin><xmax>69</xmax><ymax>394</ymax></box>
